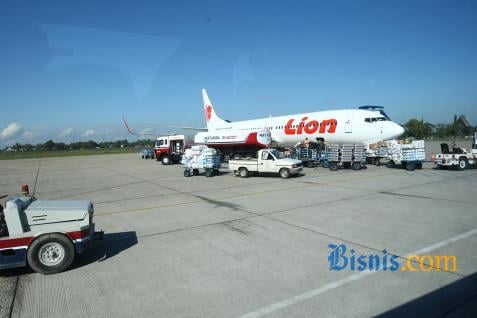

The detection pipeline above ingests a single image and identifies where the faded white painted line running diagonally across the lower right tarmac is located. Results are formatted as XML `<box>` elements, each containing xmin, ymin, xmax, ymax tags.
<box><xmin>241</xmin><ymin>229</ymin><xmax>477</xmax><ymax>318</ymax></box>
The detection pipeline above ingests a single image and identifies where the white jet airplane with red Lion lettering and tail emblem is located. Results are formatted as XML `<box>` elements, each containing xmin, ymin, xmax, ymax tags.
<box><xmin>194</xmin><ymin>89</ymin><xmax>404</xmax><ymax>147</ymax></box>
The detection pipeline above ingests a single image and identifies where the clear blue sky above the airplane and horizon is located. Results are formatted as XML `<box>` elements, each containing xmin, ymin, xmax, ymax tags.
<box><xmin>0</xmin><ymin>0</ymin><xmax>477</xmax><ymax>146</ymax></box>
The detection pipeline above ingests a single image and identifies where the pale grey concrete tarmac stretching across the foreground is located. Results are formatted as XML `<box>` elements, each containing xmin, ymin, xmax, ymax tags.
<box><xmin>0</xmin><ymin>146</ymin><xmax>477</xmax><ymax>317</ymax></box>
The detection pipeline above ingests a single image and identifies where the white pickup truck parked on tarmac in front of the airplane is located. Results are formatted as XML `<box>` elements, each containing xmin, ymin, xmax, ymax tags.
<box><xmin>229</xmin><ymin>149</ymin><xmax>303</xmax><ymax>179</ymax></box>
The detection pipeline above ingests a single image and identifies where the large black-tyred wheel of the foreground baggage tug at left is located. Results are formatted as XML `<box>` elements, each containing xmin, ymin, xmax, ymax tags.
<box><xmin>27</xmin><ymin>233</ymin><xmax>75</xmax><ymax>275</ymax></box>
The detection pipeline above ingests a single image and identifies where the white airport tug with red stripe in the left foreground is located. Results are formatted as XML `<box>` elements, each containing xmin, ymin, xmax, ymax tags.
<box><xmin>0</xmin><ymin>185</ymin><xmax>102</xmax><ymax>275</ymax></box>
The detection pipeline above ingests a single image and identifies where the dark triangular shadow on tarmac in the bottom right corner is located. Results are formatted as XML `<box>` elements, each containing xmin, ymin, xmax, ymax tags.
<box><xmin>376</xmin><ymin>273</ymin><xmax>477</xmax><ymax>318</ymax></box>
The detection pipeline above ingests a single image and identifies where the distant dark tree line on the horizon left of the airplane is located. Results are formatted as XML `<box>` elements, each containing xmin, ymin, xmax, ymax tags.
<box><xmin>4</xmin><ymin>139</ymin><xmax>154</xmax><ymax>151</ymax></box>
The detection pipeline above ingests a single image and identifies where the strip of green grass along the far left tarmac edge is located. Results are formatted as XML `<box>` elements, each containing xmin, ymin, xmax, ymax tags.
<box><xmin>0</xmin><ymin>148</ymin><xmax>139</xmax><ymax>160</ymax></box>
